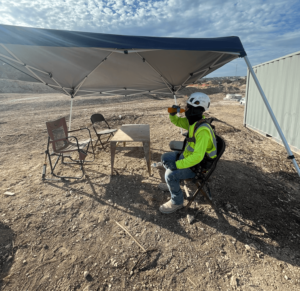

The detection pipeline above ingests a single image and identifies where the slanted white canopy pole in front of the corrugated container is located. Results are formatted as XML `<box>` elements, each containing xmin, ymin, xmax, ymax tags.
<box><xmin>244</xmin><ymin>56</ymin><xmax>300</xmax><ymax>177</ymax></box>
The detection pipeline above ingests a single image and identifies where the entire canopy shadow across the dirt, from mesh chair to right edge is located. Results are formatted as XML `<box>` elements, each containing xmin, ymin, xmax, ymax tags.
<box><xmin>44</xmin><ymin>160</ymin><xmax>300</xmax><ymax>266</ymax></box>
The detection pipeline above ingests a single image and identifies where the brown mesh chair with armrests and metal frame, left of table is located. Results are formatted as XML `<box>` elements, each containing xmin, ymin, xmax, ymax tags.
<box><xmin>42</xmin><ymin>117</ymin><xmax>95</xmax><ymax>180</ymax></box>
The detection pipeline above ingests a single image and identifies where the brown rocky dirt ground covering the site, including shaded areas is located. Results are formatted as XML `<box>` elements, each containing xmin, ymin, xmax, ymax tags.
<box><xmin>0</xmin><ymin>84</ymin><xmax>300</xmax><ymax>291</ymax></box>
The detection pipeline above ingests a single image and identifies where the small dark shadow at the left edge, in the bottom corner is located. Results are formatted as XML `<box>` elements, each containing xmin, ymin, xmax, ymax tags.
<box><xmin>0</xmin><ymin>221</ymin><xmax>16</xmax><ymax>289</ymax></box>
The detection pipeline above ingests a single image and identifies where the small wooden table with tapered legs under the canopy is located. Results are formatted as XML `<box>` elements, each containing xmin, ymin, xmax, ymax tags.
<box><xmin>110</xmin><ymin>124</ymin><xmax>151</xmax><ymax>175</ymax></box>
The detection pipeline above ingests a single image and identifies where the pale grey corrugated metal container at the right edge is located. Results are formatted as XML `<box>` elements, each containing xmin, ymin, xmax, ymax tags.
<box><xmin>244</xmin><ymin>51</ymin><xmax>300</xmax><ymax>153</ymax></box>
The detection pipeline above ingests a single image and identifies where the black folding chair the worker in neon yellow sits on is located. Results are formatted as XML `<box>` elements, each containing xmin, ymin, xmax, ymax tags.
<box><xmin>185</xmin><ymin>135</ymin><xmax>226</xmax><ymax>209</ymax></box>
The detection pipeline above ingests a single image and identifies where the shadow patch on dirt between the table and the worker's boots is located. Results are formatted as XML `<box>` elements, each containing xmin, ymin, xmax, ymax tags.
<box><xmin>46</xmin><ymin>169</ymin><xmax>191</xmax><ymax>243</ymax></box>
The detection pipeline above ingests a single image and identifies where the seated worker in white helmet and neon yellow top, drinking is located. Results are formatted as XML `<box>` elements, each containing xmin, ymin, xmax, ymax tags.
<box><xmin>159</xmin><ymin>92</ymin><xmax>217</xmax><ymax>214</ymax></box>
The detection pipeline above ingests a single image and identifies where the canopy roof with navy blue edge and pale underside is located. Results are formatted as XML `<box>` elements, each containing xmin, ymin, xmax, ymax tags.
<box><xmin>0</xmin><ymin>25</ymin><xmax>246</xmax><ymax>96</ymax></box>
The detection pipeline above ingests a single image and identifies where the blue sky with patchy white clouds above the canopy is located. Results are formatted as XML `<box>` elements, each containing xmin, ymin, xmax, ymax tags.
<box><xmin>0</xmin><ymin>0</ymin><xmax>300</xmax><ymax>77</ymax></box>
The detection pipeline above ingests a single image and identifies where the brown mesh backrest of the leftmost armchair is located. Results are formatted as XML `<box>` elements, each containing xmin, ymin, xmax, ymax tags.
<box><xmin>46</xmin><ymin>117</ymin><xmax>68</xmax><ymax>151</ymax></box>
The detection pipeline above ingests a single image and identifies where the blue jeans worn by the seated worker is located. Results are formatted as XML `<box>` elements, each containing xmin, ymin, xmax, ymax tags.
<box><xmin>161</xmin><ymin>151</ymin><xmax>196</xmax><ymax>205</ymax></box>
